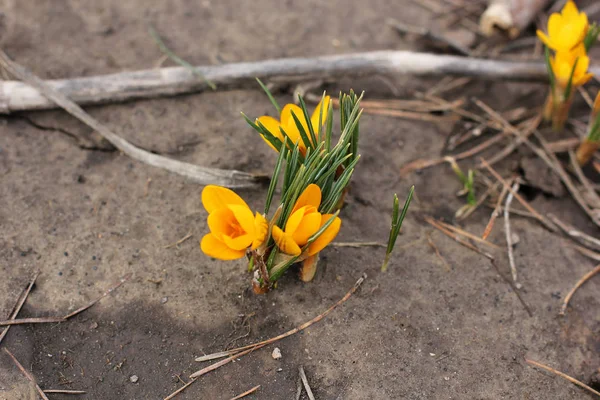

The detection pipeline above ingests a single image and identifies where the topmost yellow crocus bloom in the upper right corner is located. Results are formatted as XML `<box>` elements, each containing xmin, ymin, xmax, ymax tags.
<box><xmin>537</xmin><ymin>0</ymin><xmax>589</xmax><ymax>52</ymax></box>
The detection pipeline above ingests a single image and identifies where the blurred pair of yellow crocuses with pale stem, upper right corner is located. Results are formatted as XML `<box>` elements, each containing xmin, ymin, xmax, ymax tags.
<box><xmin>537</xmin><ymin>0</ymin><xmax>598</xmax><ymax>129</ymax></box>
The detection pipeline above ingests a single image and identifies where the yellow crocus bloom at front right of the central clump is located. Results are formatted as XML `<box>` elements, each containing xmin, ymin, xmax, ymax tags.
<box><xmin>272</xmin><ymin>184</ymin><xmax>342</xmax><ymax>256</ymax></box>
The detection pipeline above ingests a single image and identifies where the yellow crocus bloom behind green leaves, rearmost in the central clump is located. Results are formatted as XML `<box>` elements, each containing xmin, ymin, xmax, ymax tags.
<box><xmin>257</xmin><ymin>96</ymin><xmax>330</xmax><ymax>154</ymax></box>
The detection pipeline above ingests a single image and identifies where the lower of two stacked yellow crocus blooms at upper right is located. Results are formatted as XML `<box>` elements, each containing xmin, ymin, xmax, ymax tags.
<box><xmin>550</xmin><ymin>43</ymin><xmax>593</xmax><ymax>88</ymax></box>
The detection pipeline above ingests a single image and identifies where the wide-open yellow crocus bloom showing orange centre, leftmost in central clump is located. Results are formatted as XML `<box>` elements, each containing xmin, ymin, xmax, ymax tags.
<box><xmin>200</xmin><ymin>185</ymin><xmax>269</xmax><ymax>260</ymax></box>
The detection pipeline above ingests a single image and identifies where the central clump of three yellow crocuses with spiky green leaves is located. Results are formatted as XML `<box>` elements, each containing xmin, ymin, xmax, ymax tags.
<box><xmin>200</xmin><ymin>91</ymin><xmax>360</xmax><ymax>293</ymax></box>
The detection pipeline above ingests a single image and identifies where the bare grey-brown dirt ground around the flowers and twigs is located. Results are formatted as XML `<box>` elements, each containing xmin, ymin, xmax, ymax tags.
<box><xmin>0</xmin><ymin>0</ymin><xmax>600</xmax><ymax>400</ymax></box>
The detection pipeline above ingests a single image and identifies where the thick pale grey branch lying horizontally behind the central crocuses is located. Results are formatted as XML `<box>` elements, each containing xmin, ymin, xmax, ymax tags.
<box><xmin>0</xmin><ymin>51</ymin><xmax>600</xmax><ymax>113</ymax></box>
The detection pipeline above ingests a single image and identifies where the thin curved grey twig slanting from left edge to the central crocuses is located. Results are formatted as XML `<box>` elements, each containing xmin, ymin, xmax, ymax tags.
<box><xmin>0</xmin><ymin>50</ymin><xmax>266</xmax><ymax>187</ymax></box>
